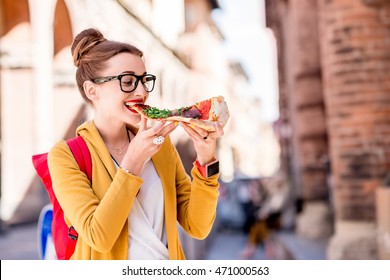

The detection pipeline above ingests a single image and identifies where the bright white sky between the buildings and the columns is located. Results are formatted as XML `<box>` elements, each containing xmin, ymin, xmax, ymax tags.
<box><xmin>213</xmin><ymin>0</ymin><xmax>279</xmax><ymax>122</ymax></box>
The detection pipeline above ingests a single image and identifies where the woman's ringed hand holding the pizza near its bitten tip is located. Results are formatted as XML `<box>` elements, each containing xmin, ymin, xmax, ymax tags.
<box><xmin>121</xmin><ymin>116</ymin><xmax>178</xmax><ymax>176</ymax></box>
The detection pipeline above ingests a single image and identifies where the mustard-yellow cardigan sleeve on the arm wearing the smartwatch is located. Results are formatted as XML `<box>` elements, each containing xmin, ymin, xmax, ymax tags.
<box><xmin>174</xmin><ymin>143</ymin><xmax>219</xmax><ymax>239</ymax></box>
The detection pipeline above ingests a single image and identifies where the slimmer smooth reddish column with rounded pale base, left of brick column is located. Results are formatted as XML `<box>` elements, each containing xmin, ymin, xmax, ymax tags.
<box><xmin>284</xmin><ymin>0</ymin><xmax>332</xmax><ymax>238</ymax></box>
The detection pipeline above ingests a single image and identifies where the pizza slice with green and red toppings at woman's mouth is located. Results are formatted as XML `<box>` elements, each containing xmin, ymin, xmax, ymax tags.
<box><xmin>128</xmin><ymin>96</ymin><xmax>229</xmax><ymax>131</ymax></box>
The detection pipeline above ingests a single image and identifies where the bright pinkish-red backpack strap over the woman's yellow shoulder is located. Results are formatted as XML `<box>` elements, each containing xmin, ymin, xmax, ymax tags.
<box><xmin>67</xmin><ymin>136</ymin><xmax>92</xmax><ymax>182</ymax></box>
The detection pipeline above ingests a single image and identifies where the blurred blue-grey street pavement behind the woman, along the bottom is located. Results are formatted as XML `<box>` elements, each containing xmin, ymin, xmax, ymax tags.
<box><xmin>0</xmin><ymin>223</ymin><xmax>327</xmax><ymax>260</ymax></box>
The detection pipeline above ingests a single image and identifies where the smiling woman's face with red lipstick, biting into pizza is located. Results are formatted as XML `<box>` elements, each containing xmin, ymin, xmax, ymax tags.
<box><xmin>93</xmin><ymin>53</ymin><xmax>149</xmax><ymax>125</ymax></box>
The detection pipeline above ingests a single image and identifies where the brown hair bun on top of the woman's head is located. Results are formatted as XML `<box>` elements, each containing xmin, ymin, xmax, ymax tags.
<box><xmin>71</xmin><ymin>28</ymin><xmax>107</xmax><ymax>67</ymax></box>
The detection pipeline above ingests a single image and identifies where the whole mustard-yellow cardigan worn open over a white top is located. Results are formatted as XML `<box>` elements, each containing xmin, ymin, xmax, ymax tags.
<box><xmin>48</xmin><ymin>121</ymin><xmax>219</xmax><ymax>260</ymax></box>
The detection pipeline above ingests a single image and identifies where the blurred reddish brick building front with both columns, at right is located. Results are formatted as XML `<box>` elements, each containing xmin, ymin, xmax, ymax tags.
<box><xmin>266</xmin><ymin>0</ymin><xmax>390</xmax><ymax>259</ymax></box>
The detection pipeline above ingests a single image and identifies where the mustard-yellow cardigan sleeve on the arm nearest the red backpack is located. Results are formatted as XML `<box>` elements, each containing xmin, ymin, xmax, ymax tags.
<box><xmin>48</xmin><ymin>141</ymin><xmax>142</xmax><ymax>252</ymax></box>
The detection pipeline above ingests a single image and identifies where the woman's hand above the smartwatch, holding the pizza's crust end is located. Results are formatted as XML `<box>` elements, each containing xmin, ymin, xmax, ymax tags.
<box><xmin>180</xmin><ymin>122</ymin><xmax>224</xmax><ymax>166</ymax></box>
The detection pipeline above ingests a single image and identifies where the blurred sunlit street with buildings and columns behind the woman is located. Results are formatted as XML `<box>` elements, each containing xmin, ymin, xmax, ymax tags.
<box><xmin>0</xmin><ymin>0</ymin><xmax>390</xmax><ymax>260</ymax></box>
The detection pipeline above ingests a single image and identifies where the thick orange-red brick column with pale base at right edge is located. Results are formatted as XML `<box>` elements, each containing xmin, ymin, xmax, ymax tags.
<box><xmin>318</xmin><ymin>0</ymin><xmax>390</xmax><ymax>259</ymax></box>
